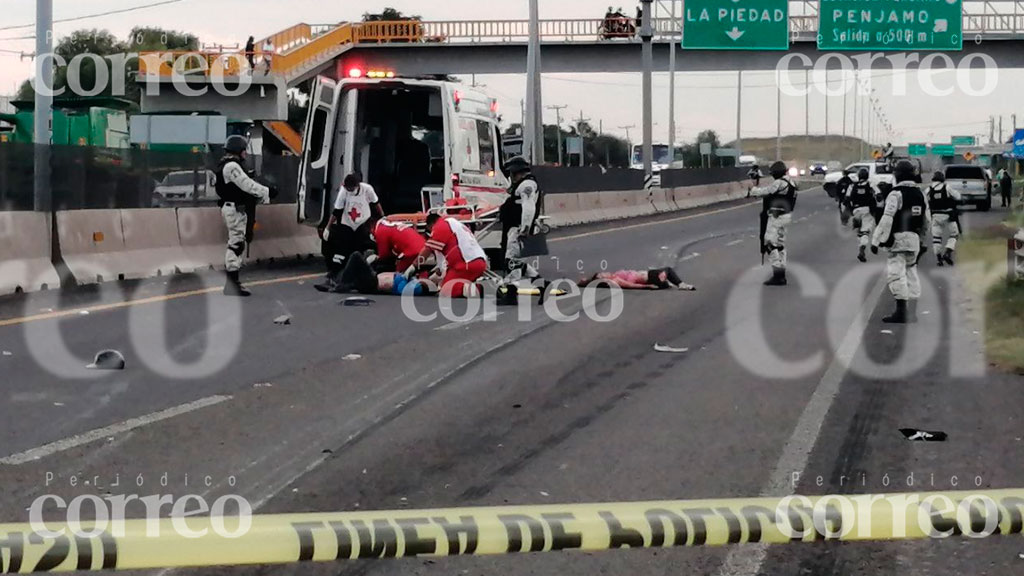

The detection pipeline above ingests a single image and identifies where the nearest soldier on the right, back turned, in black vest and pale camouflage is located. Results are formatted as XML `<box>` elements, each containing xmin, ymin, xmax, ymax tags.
<box><xmin>871</xmin><ymin>160</ymin><xmax>932</xmax><ymax>324</ymax></box>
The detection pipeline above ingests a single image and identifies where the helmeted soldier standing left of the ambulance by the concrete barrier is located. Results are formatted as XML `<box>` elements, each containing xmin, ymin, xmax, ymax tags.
<box><xmin>216</xmin><ymin>135</ymin><xmax>278</xmax><ymax>296</ymax></box>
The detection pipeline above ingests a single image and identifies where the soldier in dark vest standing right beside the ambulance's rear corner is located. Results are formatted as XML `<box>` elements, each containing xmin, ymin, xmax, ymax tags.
<box><xmin>500</xmin><ymin>156</ymin><xmax>543</xmax><ymax>282</ymax></box>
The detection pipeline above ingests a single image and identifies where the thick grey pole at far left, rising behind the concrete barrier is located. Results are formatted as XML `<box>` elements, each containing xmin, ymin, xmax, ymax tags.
<box><xmin>33</xmin><ymin>0</ymin><xmax>53</xmax><ymax>212</ymax></box>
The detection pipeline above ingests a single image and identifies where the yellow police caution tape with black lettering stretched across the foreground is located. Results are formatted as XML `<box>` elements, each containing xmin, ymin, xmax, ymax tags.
<box><xmin>0</xmin><ymin>489</ymin><xmax>1024</xmax><ymax>573</ymax></box>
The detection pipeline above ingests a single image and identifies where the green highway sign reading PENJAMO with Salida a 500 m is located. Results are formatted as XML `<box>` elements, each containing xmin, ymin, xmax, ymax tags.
<box><xmin>818</xmin><ymin>0</ymin><xmax>964</xmax><ymax>50</ymax></box>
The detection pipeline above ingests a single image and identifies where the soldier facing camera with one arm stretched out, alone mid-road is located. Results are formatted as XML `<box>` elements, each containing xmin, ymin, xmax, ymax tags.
<box><xmin>748</xmin><ymin>161</ymin><xmax>797</xmax><ymax>286</ymax></box>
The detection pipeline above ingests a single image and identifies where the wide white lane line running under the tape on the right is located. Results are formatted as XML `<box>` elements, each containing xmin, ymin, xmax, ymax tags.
<box><xmin>718</xmin><ymin>277</ymin><xmax>886</xmax><ymax>576</ymax></box>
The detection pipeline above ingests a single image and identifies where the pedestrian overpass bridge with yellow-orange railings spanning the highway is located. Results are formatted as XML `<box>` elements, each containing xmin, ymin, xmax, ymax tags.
<box><xmin>138</xmin><ymin>0</ymin><xmax>1024</xmax><ymax>138</ymax></box>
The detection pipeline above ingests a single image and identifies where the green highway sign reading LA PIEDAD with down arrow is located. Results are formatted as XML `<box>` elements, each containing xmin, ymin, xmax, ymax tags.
<box><xmin>683</xmin><ymin>0</ymin><xmax>790</xmax><ymax>50</ymax></box>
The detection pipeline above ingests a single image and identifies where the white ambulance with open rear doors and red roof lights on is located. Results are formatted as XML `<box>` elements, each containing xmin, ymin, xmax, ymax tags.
<box><xmin>298</xmin><ymin>70</ymin><xmax>509</xmax><ymax>241</ymax></box>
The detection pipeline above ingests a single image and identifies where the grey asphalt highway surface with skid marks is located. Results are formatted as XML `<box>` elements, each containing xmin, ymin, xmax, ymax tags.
<box><xmin>0</xmin><ymin>189</ymin><xmax>1024</xmax><ymax>576</ymax></box>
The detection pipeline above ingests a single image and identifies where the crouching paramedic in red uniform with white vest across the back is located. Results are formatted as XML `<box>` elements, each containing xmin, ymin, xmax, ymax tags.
<box><xmin>407</xmin><ymin>214</ymin><xmax>487</xmax><ymax>298</ymax></box>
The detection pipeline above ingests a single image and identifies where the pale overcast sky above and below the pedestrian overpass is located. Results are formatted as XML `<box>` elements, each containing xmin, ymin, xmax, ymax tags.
<box><xmin>0</xmin><ymin>0</ymin><xmax>1024</xmax><ymax>143</ymax></box>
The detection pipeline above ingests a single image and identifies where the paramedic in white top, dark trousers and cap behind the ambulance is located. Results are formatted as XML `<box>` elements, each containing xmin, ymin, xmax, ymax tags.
<box><xmin>314</xmin><ymin>173</ymin><xmax>384</xmax><ymax>292</ymax></box>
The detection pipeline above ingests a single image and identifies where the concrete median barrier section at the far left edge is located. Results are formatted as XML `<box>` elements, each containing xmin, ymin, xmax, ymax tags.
<box><xmin>0</xmin><ymin>212</ymin><xmax>60</xmax><ymax>295</ymax></box>
